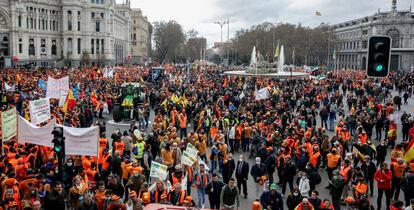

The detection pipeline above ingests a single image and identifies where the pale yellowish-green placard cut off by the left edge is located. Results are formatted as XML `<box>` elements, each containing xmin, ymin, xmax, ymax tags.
<box><xmin>1</xmin><ymin>108</ymin><xmax>17</xmax><ymax>141</ymax></box>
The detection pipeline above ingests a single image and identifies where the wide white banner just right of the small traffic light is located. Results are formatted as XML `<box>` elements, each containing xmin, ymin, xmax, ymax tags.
<box><xmin>63</xmin><ymin>126</ymin><xmax>99</xmax><ymax>157</ymax></box>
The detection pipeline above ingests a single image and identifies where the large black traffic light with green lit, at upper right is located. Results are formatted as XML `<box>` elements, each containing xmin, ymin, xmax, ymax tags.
<box><xmin>367</xmin><ymin>36</ymin><xmax>391</xmax><ymax>77</ymax></box>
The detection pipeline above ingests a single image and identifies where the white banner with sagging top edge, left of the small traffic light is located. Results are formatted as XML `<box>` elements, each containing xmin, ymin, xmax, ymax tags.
<box><xmin>17</xmin><ymin>116</ymin><xmax>55</xmax><ymax>147</ymax></box>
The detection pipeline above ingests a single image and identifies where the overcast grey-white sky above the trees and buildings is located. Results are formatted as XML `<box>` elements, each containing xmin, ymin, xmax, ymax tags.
<box><xmin>129</xmin><ymin>0</ymin><xmax>414</xmax><ymax>46</ymax></box>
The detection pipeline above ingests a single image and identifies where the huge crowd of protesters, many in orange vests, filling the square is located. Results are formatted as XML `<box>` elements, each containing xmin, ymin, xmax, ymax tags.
<box><xmin>0</xmin><ymin>64</ymin><xmax>414</xmax><ymax>210</ymax></box>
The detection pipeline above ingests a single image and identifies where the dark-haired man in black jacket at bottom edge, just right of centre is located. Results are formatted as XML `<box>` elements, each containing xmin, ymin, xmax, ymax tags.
<box><xmin>220</xmin><ymin>178</ymin><xmax>240</xmax><ymax>210</ymax></box>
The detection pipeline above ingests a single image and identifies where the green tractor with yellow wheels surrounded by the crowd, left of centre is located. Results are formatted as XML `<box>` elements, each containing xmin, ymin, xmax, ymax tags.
<box><xmin>113</xmin><ymin>83</ymin><xmax>145</xmax><ymax>122</ymax></box>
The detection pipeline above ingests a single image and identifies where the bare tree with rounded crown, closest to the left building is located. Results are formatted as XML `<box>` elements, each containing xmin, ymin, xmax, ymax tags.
<box><xmin>154</xmin><ymin>20</ymin><xmax>185</xmax><ymax>63</ymax></box>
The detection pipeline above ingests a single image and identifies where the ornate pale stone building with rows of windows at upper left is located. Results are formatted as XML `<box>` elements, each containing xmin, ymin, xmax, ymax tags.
<box><xmin>0</xmin><ymin>0</ymin><xmax>131</xmax><ymax>66</ymax></box>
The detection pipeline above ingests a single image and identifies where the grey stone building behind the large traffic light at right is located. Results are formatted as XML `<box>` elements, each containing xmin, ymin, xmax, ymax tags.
<box><xmin>330</xmin><ymin>3</ymin><xmax>414</xmax><ymax>71</ymax></box>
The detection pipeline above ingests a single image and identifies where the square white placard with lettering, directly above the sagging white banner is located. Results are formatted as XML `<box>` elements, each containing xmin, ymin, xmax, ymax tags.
<box><xmin>29</xmin><ymin>98</ymin><xmax>50</xmax><ymax>125</ymax></box>
